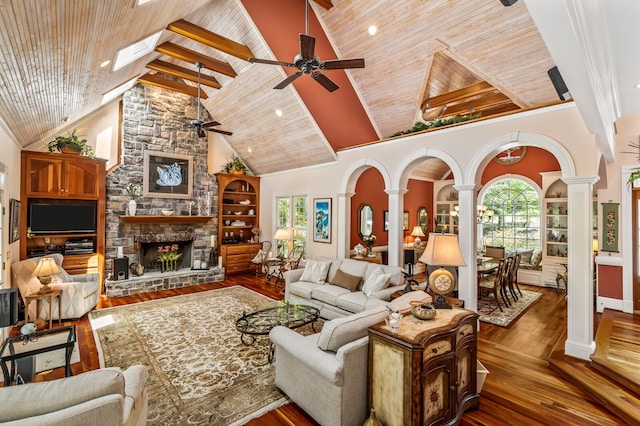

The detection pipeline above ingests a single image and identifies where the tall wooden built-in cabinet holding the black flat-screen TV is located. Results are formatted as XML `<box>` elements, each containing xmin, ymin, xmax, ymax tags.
<box><xmin>20</xmin><ymin>151</ymin><xmax>106</xmax><ymax>291</ymax></box>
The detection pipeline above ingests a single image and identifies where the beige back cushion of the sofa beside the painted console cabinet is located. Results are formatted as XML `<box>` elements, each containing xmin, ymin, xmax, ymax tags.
<box><xmin>318</xmin><ymin>307</ymin><xmax>389</xmax><ymax>352</ymax></box>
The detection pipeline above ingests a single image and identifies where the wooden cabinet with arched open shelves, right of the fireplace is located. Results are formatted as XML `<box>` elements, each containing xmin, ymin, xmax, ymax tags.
<box><xmin>216</xmin><ymin>173</ymin><xmax>261</xmax><ymax>274</ymax></box>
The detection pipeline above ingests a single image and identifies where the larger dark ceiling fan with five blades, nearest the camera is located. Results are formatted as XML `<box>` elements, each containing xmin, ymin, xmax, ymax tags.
<box><xmin>249</xmin><ymin>0</ymin><xmax>364</xmax><ymax>92</ymax></box>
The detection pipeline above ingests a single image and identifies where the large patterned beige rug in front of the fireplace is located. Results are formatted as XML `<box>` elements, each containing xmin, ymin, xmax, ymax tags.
<box><xmin>90</xmin><ymin>286</ymin><xmax>310</xmax><ymax>425</ymax></box>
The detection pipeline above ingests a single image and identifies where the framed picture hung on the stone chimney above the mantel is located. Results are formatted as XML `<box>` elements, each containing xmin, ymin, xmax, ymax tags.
<box><xmin>142</xmin><ymin>151</ymin><xmax>193</xmax><ymax>199</ymax></box>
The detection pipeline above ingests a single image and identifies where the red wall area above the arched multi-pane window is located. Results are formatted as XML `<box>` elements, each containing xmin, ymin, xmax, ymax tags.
<box><xmin>482</xmin><ymin>146</ymin><xmax>560</xmax><ymax>187</ymax></box>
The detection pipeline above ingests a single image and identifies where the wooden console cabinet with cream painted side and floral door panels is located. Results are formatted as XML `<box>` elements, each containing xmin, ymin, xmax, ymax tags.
<box><xmin>369</xmin><ymin>307</ymin><xmax>480</xmax><ymax>426</ymax></box>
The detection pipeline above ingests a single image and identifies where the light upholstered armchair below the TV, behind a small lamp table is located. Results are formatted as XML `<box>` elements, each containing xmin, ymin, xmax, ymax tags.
<box><xmin>11</xmin><ymin>253</ymin><xmax>100</xmax><ymax>320</ymax></box>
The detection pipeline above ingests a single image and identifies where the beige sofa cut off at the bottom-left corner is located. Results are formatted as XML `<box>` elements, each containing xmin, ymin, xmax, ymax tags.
<box><xmin>0</xmin><ymin>365</ymin><xmax>149</xmax><ymax>426</ymax></box>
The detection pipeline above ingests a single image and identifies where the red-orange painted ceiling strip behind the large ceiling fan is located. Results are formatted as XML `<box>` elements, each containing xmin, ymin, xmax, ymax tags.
<box><xmin>242</xmin><ymin>0</ymin><xmax>379</xmax><ymax>151</ymax></box>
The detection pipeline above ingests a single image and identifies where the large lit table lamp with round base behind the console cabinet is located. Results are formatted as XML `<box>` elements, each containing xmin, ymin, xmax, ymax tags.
<box><xmin>419</xmin><ymin>233</ymin><xmax>465</xmax><ymax>309</ymax></box>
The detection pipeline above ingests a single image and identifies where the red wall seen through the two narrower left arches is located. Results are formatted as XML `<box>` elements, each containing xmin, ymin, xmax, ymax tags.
<box><xmin>349</xmin><ymin>168</ymin><xmax>433</xmax><ymax>248</ymax></box>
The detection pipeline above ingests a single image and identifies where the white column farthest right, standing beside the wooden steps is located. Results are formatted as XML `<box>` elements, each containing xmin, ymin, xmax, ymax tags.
<box><xmin>562</xmin><ymin>176</ymin><xmax>598</xmax><ymax>360</ymax></box>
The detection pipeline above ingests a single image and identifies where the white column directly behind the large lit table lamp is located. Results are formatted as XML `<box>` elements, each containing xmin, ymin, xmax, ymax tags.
<box><xmin>453</xmin><ymin>185</ymin><xmax>478</xmax><ymax>312</ymax></box>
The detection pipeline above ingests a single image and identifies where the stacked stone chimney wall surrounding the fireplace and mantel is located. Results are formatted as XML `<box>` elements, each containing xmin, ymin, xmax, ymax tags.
<box><xmin>105</xmin><ymin>84</ymin><xmax>218</xmax><ymax>282</ymax></box>
